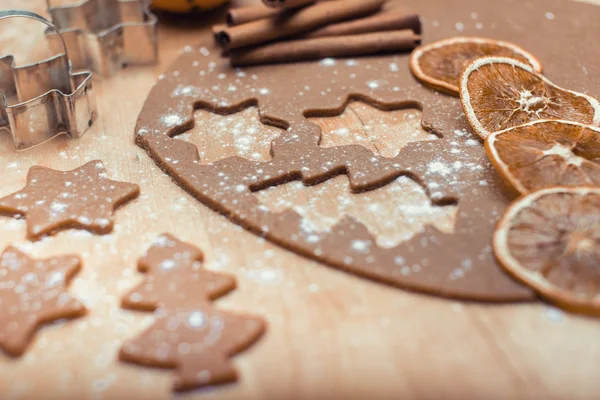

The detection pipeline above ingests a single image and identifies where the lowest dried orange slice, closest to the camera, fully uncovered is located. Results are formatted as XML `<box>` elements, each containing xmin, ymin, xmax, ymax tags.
<box><xmin>494</xmin><ymin>187</ymin><xmax>600</xmax><ymax>312</ymax></box>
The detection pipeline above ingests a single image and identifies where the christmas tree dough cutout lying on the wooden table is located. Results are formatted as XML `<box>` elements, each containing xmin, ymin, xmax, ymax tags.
<box><xmin>119</xmin><ymin>234</ymin><xmax>266</xmax><ymax>391</ymax></box>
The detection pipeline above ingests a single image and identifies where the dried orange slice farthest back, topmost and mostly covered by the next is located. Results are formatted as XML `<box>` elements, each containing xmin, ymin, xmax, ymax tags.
<box><xmin>410</xmin><ymin>36</ymin><xmax>542</xmax><ymax>96</ymax></box>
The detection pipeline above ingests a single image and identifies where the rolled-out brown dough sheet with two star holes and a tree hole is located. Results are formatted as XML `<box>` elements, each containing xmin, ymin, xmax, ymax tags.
<box><xmin>135</xmin><ymin>0</ymin><xmax>600</xmax><ymax>302</ymax></box>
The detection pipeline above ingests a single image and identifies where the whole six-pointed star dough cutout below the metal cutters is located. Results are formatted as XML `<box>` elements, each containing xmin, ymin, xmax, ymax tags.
<box><xmin>0</xmin><ymin>161</ymin><xmax>140</xmax><ymax>240</ymax></box>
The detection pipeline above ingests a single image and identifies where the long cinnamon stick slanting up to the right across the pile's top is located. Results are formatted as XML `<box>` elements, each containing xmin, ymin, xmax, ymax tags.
<box><xmin>217</xmin><ymin>0</ymin><xmax>386</xmax><ymax>49</ymax></box>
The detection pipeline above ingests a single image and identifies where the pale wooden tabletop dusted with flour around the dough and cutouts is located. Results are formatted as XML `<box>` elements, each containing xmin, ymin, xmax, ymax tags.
<box><xmin>0</xmin><ymin>0</ymin><xmax>600</xmax><ymax>400</ymax></box>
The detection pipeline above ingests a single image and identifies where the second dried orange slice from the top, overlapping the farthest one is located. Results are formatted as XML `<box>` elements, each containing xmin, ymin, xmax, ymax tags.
<box><xmin>460</xmin><ymin>57</ymin><xmax>600</xmax><ymax>139</ymax></box>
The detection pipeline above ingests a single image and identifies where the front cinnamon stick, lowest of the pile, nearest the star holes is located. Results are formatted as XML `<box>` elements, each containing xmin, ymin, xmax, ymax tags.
<box><xmin>230</xmin><ymin>29</ymin><xmax>421</xmax><ymax>67</ymax></box>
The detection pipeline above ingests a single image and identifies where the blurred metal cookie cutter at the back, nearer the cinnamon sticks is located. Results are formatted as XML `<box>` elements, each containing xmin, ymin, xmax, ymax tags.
<box><xmin>47</xmin><ymin>0</ymin><xmax>158</xmax><ymax>76</ymax></box>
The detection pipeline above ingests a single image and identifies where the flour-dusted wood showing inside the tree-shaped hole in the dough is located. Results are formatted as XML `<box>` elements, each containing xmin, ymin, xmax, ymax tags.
<box><xmin>256</xmin><ymin>176</ymin><xmax>456</xmax><ymax>248</ymax></box>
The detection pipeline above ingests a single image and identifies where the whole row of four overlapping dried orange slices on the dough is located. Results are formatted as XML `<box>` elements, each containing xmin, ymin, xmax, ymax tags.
<box><xmin>410</xmin><ymin>37</ymin><xmax>600</xmax><ymax>314</ymax></box>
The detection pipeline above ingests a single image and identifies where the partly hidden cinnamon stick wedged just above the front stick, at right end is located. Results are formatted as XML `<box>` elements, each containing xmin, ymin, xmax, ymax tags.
<box><xmin>304</xmin><ymin>8</ymin><xmax>421</xmax><ymax>38</ymax></box>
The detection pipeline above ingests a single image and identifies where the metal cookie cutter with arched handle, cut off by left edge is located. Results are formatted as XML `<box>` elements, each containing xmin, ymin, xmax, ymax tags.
<box><xmin>0</xmin><ymin>10</ymin><xmax>97</xmax><ymax>150</ymax></box>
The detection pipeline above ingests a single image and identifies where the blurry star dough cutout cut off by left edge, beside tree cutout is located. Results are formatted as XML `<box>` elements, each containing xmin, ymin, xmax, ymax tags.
<box><xmin>0</xmin><ymin>247</ymin><xmax>86</xmax><ymax>356</ymax></box>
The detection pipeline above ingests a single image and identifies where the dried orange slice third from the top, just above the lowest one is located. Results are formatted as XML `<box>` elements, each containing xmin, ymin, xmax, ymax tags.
<box><xmin>485</xmin><ymin>120</ymin><xmax>600</xmax><ymax>193</ymax></box>
